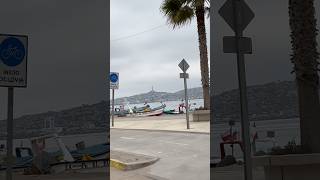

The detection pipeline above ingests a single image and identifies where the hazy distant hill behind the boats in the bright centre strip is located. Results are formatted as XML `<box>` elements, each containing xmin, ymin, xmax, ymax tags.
<box><xmin>115</xmin><ymin>87</ymin><xmax>202</xmax><ymax>105</ymax></box>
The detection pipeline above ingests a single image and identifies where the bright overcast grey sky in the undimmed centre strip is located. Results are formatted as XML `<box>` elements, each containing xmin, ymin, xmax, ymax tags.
<box><xmin>111</xmin><ymin>0</ymin><xmax>210</xmax><ymax>97</ymax></box>
